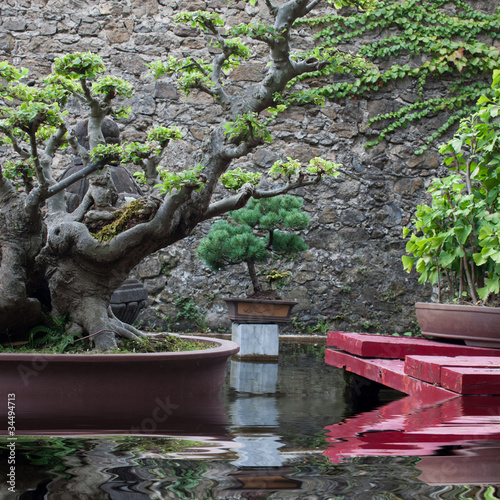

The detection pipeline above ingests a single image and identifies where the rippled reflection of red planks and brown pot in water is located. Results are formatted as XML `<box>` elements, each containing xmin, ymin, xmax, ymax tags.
<box><xmin>324</xmin><ymin>396</ymin><xmax>500</xmax><ymax>484</ymax></box>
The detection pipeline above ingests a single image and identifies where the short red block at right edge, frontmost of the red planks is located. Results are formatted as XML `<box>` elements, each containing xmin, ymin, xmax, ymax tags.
<box><xmin>441</xmin><ymin>367</ymin><xmax>500</xmax><ymax>395</ymax></box>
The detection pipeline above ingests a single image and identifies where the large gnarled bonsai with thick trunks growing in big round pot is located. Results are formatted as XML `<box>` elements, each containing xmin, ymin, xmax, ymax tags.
<box><xmin>0</xmin><ymin>0</ymin><xmax>348</xmax><ymax>350</ymax></box>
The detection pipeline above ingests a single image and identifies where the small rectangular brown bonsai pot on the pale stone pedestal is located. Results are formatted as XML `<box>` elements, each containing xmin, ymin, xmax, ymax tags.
<box><xmin>223</xmin><ymin>297</ymin><xmax>297</xmax><ymax>324</ymax></box>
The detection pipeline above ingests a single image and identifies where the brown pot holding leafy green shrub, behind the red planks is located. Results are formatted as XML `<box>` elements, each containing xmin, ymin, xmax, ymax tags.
<box><xmin>415</xmin><ymin>302</ymin><xmax>500</xmax><ymax>348</ymax></box>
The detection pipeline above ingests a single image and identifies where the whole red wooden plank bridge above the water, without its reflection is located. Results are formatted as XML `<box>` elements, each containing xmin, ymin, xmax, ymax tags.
<box><xmin>325</xmin><ymin>332</ymin><xmax>500</xmax><ymax>403</ymax></box>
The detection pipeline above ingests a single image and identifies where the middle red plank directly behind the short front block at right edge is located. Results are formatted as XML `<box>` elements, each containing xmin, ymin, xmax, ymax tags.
<box><xmin>405</xmin><ymin>356</ymin><xmax>500</xmax><ymax>384</ymax></box>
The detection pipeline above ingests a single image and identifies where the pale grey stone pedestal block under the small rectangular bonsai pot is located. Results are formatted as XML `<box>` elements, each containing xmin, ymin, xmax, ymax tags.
<box><xmin>232</xmin><ymin>323</ymin><xmax>279</xmax><ymax>360</ymax></box>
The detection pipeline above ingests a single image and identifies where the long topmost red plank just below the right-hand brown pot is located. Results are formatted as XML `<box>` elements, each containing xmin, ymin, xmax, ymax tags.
<box><xmin>327</xmin><ymin>332</ymin><xmax>500</xmax><ymax>359</ymax></box>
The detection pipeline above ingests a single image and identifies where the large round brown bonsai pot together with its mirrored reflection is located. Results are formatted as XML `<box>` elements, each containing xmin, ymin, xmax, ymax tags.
<box><xmin>0</xmin><ymin>337</ymin><xmax>239</xmax><ymax>434</ymax></box>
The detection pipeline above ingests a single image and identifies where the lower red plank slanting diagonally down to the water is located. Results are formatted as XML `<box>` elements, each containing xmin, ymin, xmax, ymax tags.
<box><xmin>325</xmin><ymin>348</ymin><xmax>456</xmax><ymax>404</ymax></box>
